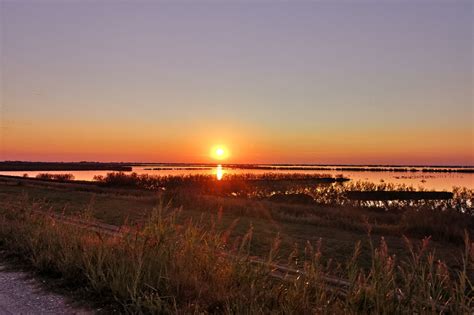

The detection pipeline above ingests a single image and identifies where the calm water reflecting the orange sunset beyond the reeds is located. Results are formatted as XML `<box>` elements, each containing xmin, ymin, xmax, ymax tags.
<box><xmin>0</xmin><ymin>164</ymin><xmax>474</xmax><ymax>191</ymax></box>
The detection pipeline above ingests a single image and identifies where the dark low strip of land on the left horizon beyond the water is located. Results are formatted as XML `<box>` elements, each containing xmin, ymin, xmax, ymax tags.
<box><xmin>0</xmin><ymin>161</ymin><xmax>132</xmax><ymax>172</ymax></box>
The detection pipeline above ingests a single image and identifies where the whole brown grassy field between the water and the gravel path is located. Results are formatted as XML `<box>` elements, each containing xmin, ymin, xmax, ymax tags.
<box><xmin>0</xmin><ymin>173</ymin><xmax>474</xmax><ymax>313</ymax></box>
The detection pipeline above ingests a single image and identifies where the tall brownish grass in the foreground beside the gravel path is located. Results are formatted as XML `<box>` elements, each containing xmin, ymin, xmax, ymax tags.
<box><xmin>0</xmin><ymin>201</ymin><xmax>474</xmax><ymax>314</ymax></box>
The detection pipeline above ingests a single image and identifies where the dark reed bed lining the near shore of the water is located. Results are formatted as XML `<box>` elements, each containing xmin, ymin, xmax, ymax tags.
<box><xmin>95</xmin><ymin>172</ymin><xmax>474</xmax><ymax>215</ymax></box>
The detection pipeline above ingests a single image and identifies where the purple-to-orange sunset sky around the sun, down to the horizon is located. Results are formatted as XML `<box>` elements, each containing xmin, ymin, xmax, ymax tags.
<box><xmin>0</xmin><ymin>0</ymin><xmax>474</xmax><ymax>165</ymax></box>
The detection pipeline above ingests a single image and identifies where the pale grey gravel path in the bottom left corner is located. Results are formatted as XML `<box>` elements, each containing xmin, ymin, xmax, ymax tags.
<box><xmin>0</xmin><ymin>262</ymin><xmax>93</xmax><ymax>314</ymax></box>
